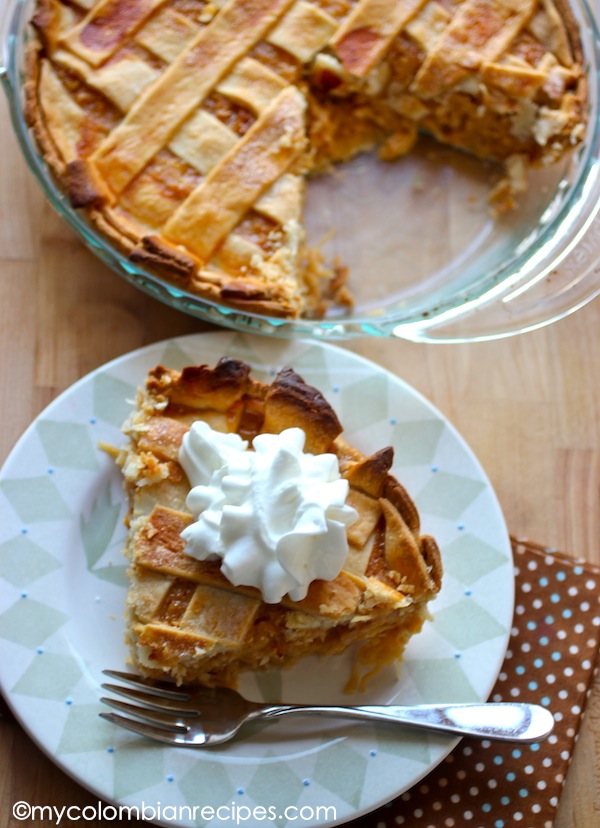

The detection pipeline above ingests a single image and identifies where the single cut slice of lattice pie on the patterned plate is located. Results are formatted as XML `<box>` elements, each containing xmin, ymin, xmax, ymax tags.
<box><xmin>119</xmin><ymin>358</ymin><xmax>442</xmax><ymax>686</ymax></box>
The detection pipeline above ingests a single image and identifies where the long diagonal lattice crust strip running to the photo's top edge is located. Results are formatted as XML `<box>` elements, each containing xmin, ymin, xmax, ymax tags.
<box><xmin>91</xmin><ymin>0</ymin><xmax>293</xmax><ymax>194</ymax></box>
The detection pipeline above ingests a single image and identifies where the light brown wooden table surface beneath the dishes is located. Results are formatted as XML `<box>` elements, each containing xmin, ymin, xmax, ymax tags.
<box><xmin>0</xmin><ymin>59</ymin><xmax>600</xmax><ymax>828</ymax></box>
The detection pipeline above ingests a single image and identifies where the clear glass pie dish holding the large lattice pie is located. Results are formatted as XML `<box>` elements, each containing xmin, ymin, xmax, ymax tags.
<box><xmin>0</xmin><ymin>0</ymin><xmax>600</xmax><ymax>342</ymax></box>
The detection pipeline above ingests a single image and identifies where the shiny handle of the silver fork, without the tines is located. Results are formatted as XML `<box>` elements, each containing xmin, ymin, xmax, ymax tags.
<box><xmin>253</xmin><ymin>702</ymin><xmax>554</xmax><ymax>743</ymax></box>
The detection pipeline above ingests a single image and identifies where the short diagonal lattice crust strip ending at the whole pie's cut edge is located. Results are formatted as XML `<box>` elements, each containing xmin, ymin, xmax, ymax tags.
<box><xmin>163</xmin><ymin>86</ymin><xmax>306</xmax><ymax>262</ymax></box>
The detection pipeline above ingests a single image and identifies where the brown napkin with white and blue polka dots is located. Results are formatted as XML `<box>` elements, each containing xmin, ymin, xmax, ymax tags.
<box><xmin>351</xmin><ymin>540</ymin><xmax>600</xmax><ymax>828</ymax></box>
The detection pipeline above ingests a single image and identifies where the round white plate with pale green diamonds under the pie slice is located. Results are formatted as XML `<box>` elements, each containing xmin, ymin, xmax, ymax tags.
<box><xmin>0</xmin><ymin>332</ymin><xmax>514</xmax><ymax>828</ymax></box>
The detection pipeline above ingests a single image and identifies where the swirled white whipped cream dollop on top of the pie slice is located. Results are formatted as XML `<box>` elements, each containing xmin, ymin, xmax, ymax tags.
<box><xmin>179</xmin><ymin>421</ymin><xmax>358</xmax><ymax>603</ymax></box>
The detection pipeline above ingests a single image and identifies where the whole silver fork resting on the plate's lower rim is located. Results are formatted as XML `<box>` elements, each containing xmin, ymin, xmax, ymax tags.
<box><xmin>100</xmin><ymin>670</ymin><xmax>554</xmax><ymax>747</ymax></box>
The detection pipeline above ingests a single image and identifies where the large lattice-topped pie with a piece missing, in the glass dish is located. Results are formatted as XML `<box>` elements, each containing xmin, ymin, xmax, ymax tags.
<box><xmin>26</xmin><ymin>0</ymin><xmax>587</xmax><ymax>317</ymax></box>
